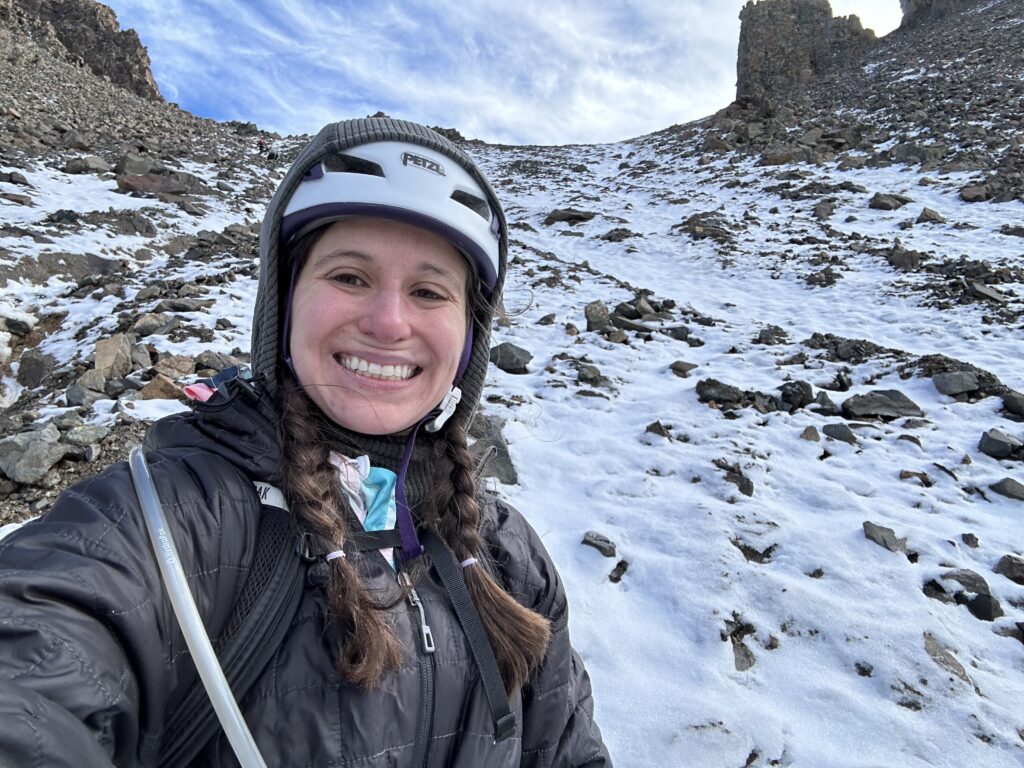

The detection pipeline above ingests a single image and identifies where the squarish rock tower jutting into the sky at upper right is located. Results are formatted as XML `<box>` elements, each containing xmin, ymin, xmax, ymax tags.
<box><xmin>736</xmin><ymin>0</ymin><xmax>876</xmax><ymax>103</ymax></box>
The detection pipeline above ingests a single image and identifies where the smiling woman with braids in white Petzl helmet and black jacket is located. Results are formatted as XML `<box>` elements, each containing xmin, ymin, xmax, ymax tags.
<box><xmin>0</xmin><ymin>119</ymin><xmax>610</xmax><ymax>768</ymax></box>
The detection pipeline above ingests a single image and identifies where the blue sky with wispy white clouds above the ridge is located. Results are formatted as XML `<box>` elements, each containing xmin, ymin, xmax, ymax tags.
<box><xmin>106</xmin><ymin>0</ymin><xmax>901</xmax><ymax>144</ymax></box>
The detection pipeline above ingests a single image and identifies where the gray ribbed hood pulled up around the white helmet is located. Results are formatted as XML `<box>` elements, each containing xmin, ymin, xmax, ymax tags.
<box><xmin>250</xmin><ymin>118</ymin><xmax>508</xmax><ymax>436</ymax></box>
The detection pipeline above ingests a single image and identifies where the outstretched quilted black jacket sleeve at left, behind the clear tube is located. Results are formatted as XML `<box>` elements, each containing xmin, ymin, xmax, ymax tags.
<box><xmin>0</xmin><ymin>450</ymin><xmax>252</xmax><ymax>768</ymax></box>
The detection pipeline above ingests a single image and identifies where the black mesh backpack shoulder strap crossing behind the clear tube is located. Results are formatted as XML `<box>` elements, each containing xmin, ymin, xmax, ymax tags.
<box><xmin>159</xmin><ymin>483</ymin><xmax>305</xmax><ymax>768</ymax></box>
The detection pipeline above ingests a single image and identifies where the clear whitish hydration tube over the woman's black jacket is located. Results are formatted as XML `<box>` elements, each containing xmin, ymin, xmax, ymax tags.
<box><xmin>128</xmin><ymin>445</ymin><xmax>266</xmax><ymax>768</ymax></box>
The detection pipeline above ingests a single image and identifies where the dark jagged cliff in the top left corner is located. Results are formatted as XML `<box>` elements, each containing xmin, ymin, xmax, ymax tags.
<box><xmin>0</xmin><ymin>0</ymin><xmax>163</xmax><ymax>101</ymax></box>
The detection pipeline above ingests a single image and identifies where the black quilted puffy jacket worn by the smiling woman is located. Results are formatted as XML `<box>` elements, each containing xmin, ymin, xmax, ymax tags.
<box><xmin>0</xmin><ymin>387</ymin><xmax>611</xmax><ymax>768</ymax></box>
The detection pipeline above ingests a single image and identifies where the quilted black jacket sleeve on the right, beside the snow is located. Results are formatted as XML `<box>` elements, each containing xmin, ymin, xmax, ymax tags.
<box><xmin>485</xmin><ymin>501</ymin><xmax>611</xmax><ymax>768</ymax></box>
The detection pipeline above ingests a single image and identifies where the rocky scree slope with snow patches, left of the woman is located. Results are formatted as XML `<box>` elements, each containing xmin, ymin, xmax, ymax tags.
<box><xmin>0</xmin><ymin>2</ymin><xmax>290</xmax><ymax>520</ymax></box>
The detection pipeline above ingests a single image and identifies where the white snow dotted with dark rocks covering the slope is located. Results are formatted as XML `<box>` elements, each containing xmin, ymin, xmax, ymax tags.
<box><xmin>0</xmin><ymin>121</ymin><xmax>1024</xmax><ymax>768</ymax></box>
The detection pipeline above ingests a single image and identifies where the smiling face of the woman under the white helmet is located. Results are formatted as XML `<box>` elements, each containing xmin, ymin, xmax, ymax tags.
<box><xmin>290</xmin><ymin>218</ymin><xmax>469</xmax><ymax>434</ymax></box>
